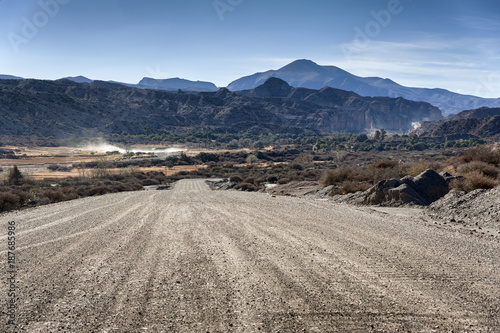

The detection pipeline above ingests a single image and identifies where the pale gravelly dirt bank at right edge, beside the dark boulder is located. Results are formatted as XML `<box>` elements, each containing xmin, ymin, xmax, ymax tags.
<box><xmin>426</xmin><ymin>187</ymin><xmax>500</xmax><ymax>233</ymax></box>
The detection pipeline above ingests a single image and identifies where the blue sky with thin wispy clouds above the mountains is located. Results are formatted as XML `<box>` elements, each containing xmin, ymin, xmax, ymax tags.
<box><xmin>0</xmin><ymin>0</ymin><xmax>500</xmax><ymax>97</ymax></box>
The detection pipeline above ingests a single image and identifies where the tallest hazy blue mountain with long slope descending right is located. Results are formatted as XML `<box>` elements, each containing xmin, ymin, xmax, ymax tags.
<box><xmin>227</xmin><ymin>59</ymin><xmax>500</xmax><ymax>115</ymax></box>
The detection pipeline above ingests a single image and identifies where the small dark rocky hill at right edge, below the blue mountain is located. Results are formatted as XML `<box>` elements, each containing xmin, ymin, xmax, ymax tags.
<box><xmin>417</xmin><ymin>107</ymin><xmax>500</xmax><ymax>139</ymax></box>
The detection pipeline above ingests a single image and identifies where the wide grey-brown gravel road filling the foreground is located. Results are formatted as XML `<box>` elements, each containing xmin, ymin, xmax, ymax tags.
<box><xmin>0</xmin><ymin>180</ymin><xmax>500</xmax><ymax>332</ymax></box>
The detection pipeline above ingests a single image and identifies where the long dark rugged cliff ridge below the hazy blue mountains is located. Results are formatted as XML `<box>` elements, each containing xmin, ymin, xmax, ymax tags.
<box><xmin>0</xmin><ymin>78</ymin><xmax>443</xmax><ymax>137</ymax></box>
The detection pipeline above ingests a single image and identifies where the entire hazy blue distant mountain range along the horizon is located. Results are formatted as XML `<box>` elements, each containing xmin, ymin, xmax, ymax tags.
<box><xmin>0</xmin><ymin>60</ymin><xmax>500</xmax><ymax>116</ymax></box>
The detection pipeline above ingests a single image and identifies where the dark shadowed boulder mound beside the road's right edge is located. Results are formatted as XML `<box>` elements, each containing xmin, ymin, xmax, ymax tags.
<box><xmin>334</xmin><ymin>169</ymin><xmax>453</xmax><ymax>206</ymax></box>
